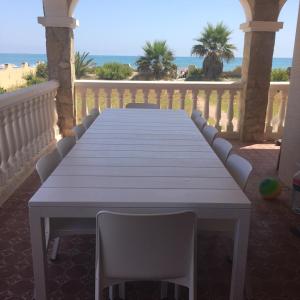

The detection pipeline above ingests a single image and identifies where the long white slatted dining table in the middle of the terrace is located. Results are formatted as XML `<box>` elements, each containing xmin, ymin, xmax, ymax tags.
<box><xmin>29</xmin><ymin>109</ymin><xmax>251</xmax><ymax>300</ymax></box>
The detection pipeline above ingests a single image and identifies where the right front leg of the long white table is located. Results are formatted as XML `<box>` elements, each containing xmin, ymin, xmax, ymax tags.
<box><xmin>230</xmin><ymin>212</ymin><xmax>250</xmax><ymax>300</ymax></box>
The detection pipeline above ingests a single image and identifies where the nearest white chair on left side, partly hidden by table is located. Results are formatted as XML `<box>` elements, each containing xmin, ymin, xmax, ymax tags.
<box><xmin>36</xmin><ymin>148</ymin><xmax>96</xmax><ymax>260</ymax></box>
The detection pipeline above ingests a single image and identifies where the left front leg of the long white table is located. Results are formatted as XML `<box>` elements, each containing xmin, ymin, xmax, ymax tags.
<box><xmin>29</xmin><ymin>208</ymin><xmax>47</xmax><ymax>300</ymax></box>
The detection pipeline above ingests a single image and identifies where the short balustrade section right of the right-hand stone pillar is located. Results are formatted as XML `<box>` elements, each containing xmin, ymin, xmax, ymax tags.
<box><xmin>265</xmin><ymin>82</ymin><xmax>289</xmax><ymax>140</ymax></box>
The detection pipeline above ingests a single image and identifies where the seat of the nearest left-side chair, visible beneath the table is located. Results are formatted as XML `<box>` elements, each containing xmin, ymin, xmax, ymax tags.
<box><xmin>50</xmin><ymin>218</ymin><xmax>96</xmax><ymax>238</ymax></box>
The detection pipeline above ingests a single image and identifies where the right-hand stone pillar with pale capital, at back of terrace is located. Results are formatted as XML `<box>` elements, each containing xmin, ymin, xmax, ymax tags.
<box><xmin>240</xmin><ymin>0</ymin><xmax>283</xmax><ymax>142</ymax></box>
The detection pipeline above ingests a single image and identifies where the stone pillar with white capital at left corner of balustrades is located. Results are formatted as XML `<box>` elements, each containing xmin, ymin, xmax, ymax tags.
<box><xmin>39</xmin><ymin>17</ymin><xmax>77</xmax><ymax>136</ymax></box>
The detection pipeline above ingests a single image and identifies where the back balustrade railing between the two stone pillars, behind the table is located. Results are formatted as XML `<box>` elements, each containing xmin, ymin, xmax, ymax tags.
<box><xmin>75</xmin><ymin>80</ymin><xmax>242</xmax><ymax>137</ymax></box>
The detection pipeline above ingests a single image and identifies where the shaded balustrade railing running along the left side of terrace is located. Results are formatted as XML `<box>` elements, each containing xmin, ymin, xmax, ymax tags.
<box><xmin>0</xmin><ymin>81</ymin><xmax>59</xmax><ymax>204</ymax></box>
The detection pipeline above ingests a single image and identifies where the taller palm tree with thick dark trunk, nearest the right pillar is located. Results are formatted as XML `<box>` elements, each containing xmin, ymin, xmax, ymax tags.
<box><xmin>192</xmin><ymin>22</ymin><xmax>236</xmax><ymax>80</ymax></box>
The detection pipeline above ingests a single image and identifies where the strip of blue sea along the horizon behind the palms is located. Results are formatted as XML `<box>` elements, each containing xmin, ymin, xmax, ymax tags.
<box><xmin>0</xmin><ymin>53</ymin><xmax>292</xmax><ymax>71</ymax></box>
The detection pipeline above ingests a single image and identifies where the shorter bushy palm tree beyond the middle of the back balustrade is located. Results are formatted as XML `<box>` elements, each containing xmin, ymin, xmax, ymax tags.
<box><xmin>136</xmin><ymin>41</ymin><xmax>177</xmax><ymax>79</ymax></box>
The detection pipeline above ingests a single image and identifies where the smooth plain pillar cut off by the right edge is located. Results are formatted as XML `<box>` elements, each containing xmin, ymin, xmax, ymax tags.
<box><xmin>279</xmin><ymin>2</ymin><xmax>300</xmax><ymax>186</ymax></box>
